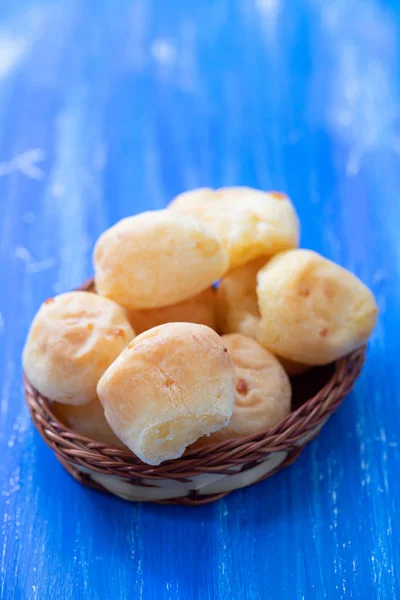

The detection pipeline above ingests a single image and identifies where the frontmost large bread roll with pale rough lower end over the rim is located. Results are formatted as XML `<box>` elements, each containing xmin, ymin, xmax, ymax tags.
<box><xmin>97</xmin><ymin>323</ymin><xmax>235</xmax><ymax>465</ymax></box>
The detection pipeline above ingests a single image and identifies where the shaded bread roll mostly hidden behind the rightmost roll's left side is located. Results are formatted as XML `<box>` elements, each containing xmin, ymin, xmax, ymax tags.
<box><xmin>217</xmin><ymin>256</ymin><xmax>267</xmax><ymax>338</ymax></box>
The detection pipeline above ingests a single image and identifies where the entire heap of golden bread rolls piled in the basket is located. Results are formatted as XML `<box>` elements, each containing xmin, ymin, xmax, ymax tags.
<box><xmin>23</xmin><ymin>187</ymin><xmax>377</xmax><ymax>465</ymax></box>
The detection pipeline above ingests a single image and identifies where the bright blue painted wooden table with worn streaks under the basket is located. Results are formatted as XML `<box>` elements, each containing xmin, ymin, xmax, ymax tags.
<box><xmin>0</xmin><ymin>0</ymin><xmax>400</xmax><ymax>600</ymax></box>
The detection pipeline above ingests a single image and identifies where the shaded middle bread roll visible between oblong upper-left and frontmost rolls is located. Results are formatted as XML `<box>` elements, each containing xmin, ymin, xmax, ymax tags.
<box><xmin>126</xmin><ymin>288</ymin><xmax>217</xmax><ymax>335</ymax></box>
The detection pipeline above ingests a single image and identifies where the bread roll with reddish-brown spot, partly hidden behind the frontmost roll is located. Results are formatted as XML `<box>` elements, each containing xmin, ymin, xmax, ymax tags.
<box><xmin>196</xmin><ymin>333</ymin><xmax>292</xmax><ymax>447</ymax></box>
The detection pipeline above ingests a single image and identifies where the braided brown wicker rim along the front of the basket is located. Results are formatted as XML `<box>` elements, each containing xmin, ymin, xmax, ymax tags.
<box><xmin>24</xmin><ymin>279</ymin><xmax>366</xmax><ymax>485</ymax></box>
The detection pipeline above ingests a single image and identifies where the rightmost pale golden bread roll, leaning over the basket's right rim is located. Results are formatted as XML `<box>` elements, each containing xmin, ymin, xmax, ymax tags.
<box><xmin>257</xmin><ymin>250</ymin><xmax>378</xmax><ymax>365</ymax></box>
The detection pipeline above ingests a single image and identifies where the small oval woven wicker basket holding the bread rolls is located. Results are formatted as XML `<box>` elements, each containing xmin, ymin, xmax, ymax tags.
<box><xmin>24</xmin><ymin>281</ymin><xmax>365</xmax><ymax>506</ymax></box>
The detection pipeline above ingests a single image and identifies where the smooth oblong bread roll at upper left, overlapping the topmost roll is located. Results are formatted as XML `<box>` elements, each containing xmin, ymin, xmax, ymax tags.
<box><xmin>93</xmin><ymin>210</ymin><xmax>228</xmax><ymax>309</ymax></box>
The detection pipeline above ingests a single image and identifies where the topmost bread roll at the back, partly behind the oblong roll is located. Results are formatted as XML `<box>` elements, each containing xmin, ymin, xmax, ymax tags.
<box><xmin>169</xmin><ymin>187</ymin><xmax>299</xmax><ymax>269</ymax></box>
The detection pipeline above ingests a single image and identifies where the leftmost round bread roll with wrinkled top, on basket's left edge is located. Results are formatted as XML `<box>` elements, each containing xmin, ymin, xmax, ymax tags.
<box><xmin>22</xmin><ymin>292</ymin><xmax>134</xmax><ymax>405</ymax></box>
